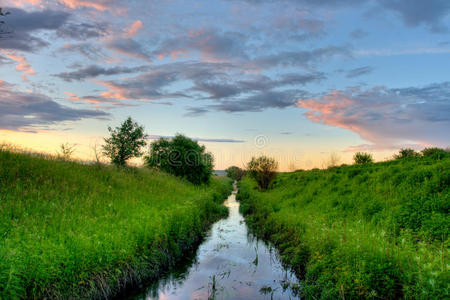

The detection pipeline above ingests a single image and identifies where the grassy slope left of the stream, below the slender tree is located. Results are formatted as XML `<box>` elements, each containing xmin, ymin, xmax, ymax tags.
<box><xmin>0</xmin><ymin>151</ymin><xmax>231</xmax><ymax>299</ymax></box>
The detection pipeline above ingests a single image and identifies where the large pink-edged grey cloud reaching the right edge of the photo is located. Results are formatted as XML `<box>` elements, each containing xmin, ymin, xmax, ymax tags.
<box><xmin>297</xmin><ymin>82</ymin><xmax>450</xmax><ymax>150</ymax></box>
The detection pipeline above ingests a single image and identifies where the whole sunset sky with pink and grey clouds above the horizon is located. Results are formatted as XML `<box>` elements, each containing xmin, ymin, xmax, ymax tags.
<box><xmin>0</xmin><ymin>0</ymin><xmax>450</xmax><ymax>171</ymax></box>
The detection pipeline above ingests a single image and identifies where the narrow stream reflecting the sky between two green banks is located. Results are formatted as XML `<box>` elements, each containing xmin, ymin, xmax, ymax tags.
<box><xmin>133</xmin><ymin>184</ymin><xmax>298</xmax><ymax>299</ymax></box>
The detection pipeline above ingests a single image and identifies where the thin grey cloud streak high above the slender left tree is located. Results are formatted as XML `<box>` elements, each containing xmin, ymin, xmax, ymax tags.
<box><xmin>54</xmin><ymin>65</ymin><xmax>149</xmax><ymax>82</ymax></box>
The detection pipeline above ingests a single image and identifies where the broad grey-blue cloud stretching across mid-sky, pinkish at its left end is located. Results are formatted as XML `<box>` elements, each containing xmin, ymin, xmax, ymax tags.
<box><xmin>75</xmin><ymin>62</ymin><xmax>326</xmax><ymax>112</ymax></box>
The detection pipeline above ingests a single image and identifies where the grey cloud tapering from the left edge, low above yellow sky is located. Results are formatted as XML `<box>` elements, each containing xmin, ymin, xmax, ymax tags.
<box><xmin>0</xmin><ymin>81</ymin><xmax>108</xmax><ymax>131</ymax></box>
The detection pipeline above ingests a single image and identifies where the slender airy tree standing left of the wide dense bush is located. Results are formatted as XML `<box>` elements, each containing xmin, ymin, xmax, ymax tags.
<box><xmin>102</xmin><ymin>117</ymin><xmax>147</xmax><ymax>167</ymax></box>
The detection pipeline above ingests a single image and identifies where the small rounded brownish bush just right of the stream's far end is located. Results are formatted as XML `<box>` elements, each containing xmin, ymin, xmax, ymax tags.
<box><xmin>247</xmin><ymin>155</ymin><xmax>278</xmax><ymax>190</ymax></box>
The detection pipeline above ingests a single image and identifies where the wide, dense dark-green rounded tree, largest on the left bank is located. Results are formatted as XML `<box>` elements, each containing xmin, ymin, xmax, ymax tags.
<box><xmin>145</xmin><ymin>134</ymin><xmax>214</xmax><ymax>184</ymax></box>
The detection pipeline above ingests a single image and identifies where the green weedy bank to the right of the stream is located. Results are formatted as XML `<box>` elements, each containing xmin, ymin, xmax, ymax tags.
<box><xmin>238</xmin><ymin>157</ymin><xmax>450</xmax><ymax>299</ymax></box>
